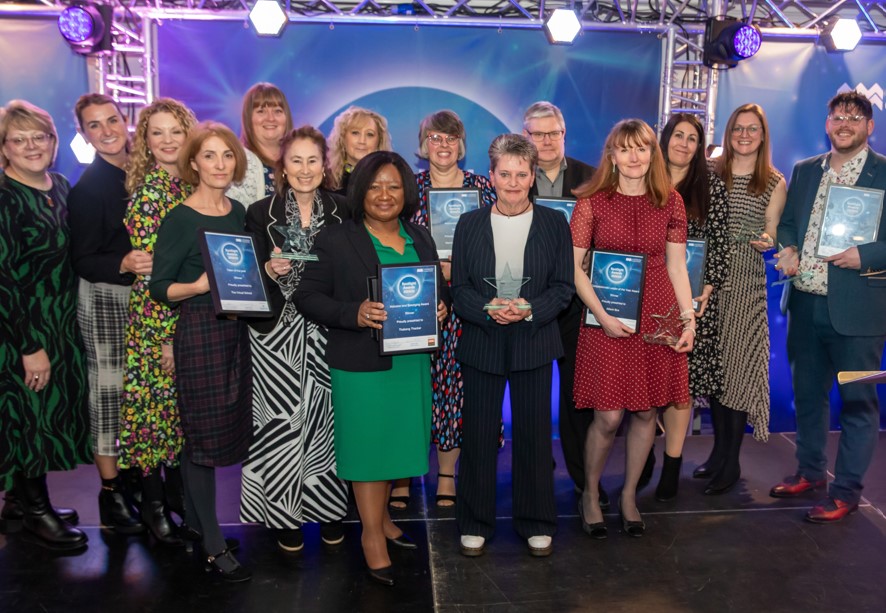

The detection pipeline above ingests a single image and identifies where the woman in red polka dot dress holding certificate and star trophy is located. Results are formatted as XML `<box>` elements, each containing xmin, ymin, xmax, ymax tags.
<box><xmin>572</xmin><ymin>119</ymin><xmax>695</xmax><ymax>538</ymax></box>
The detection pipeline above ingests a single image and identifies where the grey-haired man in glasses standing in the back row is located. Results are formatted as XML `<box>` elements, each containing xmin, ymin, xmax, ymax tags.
<box><xmin>523</xmin><ymin>101</ymin><xmax>609</xmax><ymax>498</ymax></box>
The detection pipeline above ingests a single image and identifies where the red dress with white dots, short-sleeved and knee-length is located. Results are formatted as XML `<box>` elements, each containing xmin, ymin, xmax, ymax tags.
<box><xmin>571</xmin><ymin>191</ymin><xmax>689</xmax><ymax>411</ymax></box>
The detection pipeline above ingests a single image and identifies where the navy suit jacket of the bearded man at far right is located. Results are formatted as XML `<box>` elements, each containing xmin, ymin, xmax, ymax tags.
<box><xmin>778</xmin><ymin>151</ymin><xmax>886</xmax><ymax>336</ymax></box>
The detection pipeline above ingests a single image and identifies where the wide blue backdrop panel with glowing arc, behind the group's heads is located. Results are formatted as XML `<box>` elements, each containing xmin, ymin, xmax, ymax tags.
<box><xmin>158</xmin><ymin>22</ymin><xmax>661</xmax><ymax>174</ymax></box>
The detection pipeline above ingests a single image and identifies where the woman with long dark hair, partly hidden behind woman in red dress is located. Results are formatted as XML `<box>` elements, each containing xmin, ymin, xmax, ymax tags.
<box><xmin>655</xmin><ymin>113</ymin><xmax>730</xmax><ymax>502</ymax></box>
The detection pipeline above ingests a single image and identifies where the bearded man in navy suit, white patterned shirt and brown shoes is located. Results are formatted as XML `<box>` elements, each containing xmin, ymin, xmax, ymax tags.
<box><xmin>770</xmin><ymin>91</ymin><xmax>886</xmax><ymax>523</ymax></box>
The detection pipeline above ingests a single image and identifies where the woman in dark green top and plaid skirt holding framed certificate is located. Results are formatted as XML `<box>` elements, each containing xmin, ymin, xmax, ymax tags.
<box><xmin>149</xmin><ymin>121</ymin><xmax>252</xmax><ymax>582</ymax></box>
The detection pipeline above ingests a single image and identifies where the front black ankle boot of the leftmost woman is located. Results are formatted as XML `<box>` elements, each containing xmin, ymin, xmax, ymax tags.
<box><xmin>16</xmin><ymin>475</ymin><xmax>89</xmax><ymax>551</ymax></box>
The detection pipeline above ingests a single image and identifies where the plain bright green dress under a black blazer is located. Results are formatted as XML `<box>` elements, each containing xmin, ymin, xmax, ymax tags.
<box><xmin>330</xmin><ymin>224</ymin><xmax>432</xmax><ymax>481</ymax></box>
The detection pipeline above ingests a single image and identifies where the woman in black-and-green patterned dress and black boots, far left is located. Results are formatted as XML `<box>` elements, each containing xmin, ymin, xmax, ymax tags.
<box><xmin>0</xmin><ymin>100</ymin><xmax>92</xmax><ymax>550</ymax></box>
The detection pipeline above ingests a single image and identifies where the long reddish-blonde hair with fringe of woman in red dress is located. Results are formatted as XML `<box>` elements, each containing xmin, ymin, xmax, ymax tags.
<box><xmin>572</xmin><ymin>119</ymin><xmax>671</xmax><ymax>209</ymax></box>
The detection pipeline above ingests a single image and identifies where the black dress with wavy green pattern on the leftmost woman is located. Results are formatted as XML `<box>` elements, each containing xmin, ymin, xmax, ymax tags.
<box><xmin>0</xmin><ymin>174</ymin><xmax>92</xmax><ymax>489</ymax></box>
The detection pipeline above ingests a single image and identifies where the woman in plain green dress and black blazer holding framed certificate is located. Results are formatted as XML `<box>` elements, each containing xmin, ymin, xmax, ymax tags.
<box><xmin>295</xmin><ymin>151</ymin><xmax>449</xmax><ymax>585</ymax></box>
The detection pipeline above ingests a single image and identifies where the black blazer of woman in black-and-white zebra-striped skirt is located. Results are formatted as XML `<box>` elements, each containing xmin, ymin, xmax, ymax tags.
<box><xmin>246</xmin><ymin>190</ymin><xmax>345</xmax><ymax>334</ymax></box>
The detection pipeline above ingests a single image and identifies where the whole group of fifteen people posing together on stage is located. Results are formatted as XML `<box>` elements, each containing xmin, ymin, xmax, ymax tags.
<box><xmin>0</xmin><ymin>83</ymin><xmax>886</xmax><ymax>585</ymax></box>
